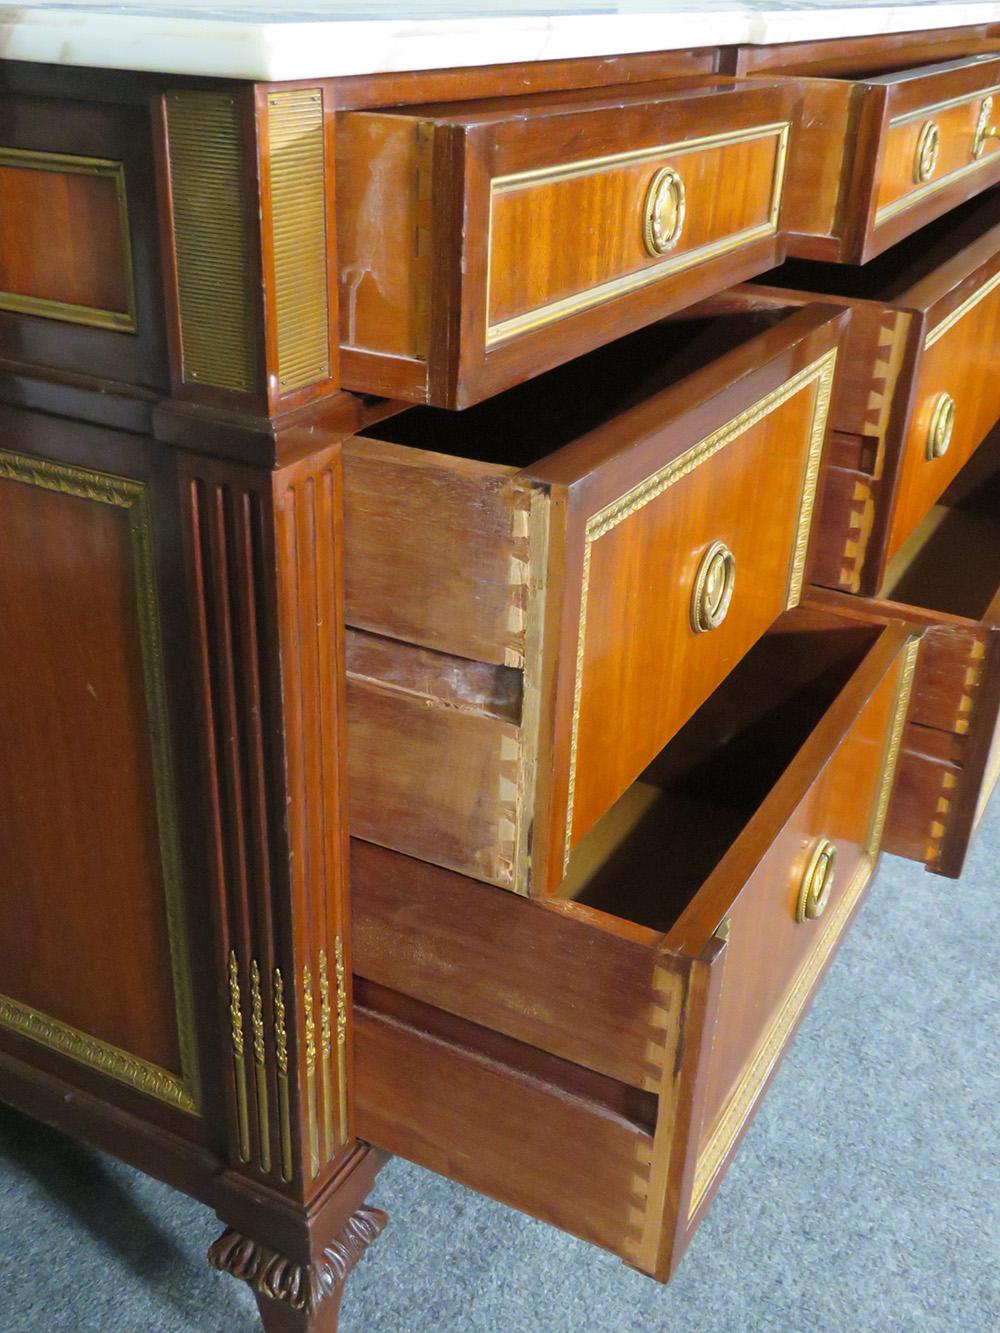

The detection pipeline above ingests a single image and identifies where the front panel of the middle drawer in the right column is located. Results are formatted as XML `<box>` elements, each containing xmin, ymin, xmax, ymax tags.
<box><xmin>884</xmin><ymin>247</ymin><xmax>1000</xmax><ymax>560</ymax></box>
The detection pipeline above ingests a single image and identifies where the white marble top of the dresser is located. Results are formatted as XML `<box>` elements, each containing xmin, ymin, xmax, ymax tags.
<box><xmin>0</xmin><ymin>0</ymin><xmax>1000</xmax><ymax>79</ymax></box>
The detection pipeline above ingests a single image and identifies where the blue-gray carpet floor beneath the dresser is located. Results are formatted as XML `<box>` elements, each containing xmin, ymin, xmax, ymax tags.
<box><xmin>0</xmin><ymin>801</ymin><xmax>1000</xmax><ymax>1333</ymax></box>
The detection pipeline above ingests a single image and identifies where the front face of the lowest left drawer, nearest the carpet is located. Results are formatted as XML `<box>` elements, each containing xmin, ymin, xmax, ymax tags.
<box><xmin>681</xmin><ymin>632</ymin><xmax>919</xmax><ymax>1218</ymax></box>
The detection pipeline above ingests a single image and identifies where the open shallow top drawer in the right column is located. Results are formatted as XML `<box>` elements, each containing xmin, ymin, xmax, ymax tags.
<box><xmin>733</xmin><ymin>37</ymin><xmax>1000</xmax><ymax>264</ymax></box>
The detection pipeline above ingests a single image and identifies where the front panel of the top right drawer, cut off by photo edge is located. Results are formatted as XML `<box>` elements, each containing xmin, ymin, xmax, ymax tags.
<box><xmin>859</xmin><ymin>55</ymin><xmax>1000</xmax><ymax>259</ymax></box>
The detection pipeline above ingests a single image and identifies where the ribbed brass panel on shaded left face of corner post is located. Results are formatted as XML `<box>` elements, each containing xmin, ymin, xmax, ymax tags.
<box><xmin>167</xmin><ymin>92</ymin><xmax>255</xmax><ymax>391</ymax></box>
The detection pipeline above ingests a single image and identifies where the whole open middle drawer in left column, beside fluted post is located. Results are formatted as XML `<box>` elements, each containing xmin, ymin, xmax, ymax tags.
<box><xmin>344</xmin><ymin>307</ymin><xmax>844</xmax><ymax>893</ymax></box>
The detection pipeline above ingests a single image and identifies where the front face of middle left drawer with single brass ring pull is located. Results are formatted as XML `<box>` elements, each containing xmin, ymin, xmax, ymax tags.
<box><xmin>547</xmin><ymin>308</ymin><xmax>841</xmax><ymax>881</ymax></box>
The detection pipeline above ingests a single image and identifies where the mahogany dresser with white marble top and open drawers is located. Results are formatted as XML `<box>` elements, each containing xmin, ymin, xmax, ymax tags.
<box><xmin>0</xmin><ymin>0</ymin><xmax>1000</xmax><ymax>1333</ymax></box>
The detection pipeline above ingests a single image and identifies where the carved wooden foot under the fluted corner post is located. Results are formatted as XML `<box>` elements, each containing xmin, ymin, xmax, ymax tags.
<box><xmin>208</xmin><ymin>1204</ymin><xmax>389</xmax><ymax>1333</ymax></box>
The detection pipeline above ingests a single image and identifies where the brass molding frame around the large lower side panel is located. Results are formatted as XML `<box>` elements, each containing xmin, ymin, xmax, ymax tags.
<box><xmin>0</xmin><ymin>449</ymin><xmax>200</xmax><ymax>1114</ymax></box>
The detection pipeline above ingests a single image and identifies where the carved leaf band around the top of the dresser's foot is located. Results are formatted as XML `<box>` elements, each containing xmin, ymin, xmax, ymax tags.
<box><xmin>208</xmin><ymin>1204</ymin><xmax>389</xmax><ymax>1314</ymax></box>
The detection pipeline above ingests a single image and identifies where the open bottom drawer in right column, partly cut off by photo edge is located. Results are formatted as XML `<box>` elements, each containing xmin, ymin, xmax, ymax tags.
<box><xmin>811</xmin><ymin>428</ymin><xmax>1000</xmax><ymax>877</ymax></box>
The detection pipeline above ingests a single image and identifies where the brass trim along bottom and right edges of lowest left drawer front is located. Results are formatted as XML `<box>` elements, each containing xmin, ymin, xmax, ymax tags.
<box><xmin>688</xmin><ymin>640</ymin><xmax>920</xmax><ymax>1218</ymax></box>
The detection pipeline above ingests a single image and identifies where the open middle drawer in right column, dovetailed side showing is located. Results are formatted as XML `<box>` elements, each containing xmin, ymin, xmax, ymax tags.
<box><xmin>692</xmin><ymin>191</ymin><xmax>1000</xmax><ymax>593</ymax></box>
